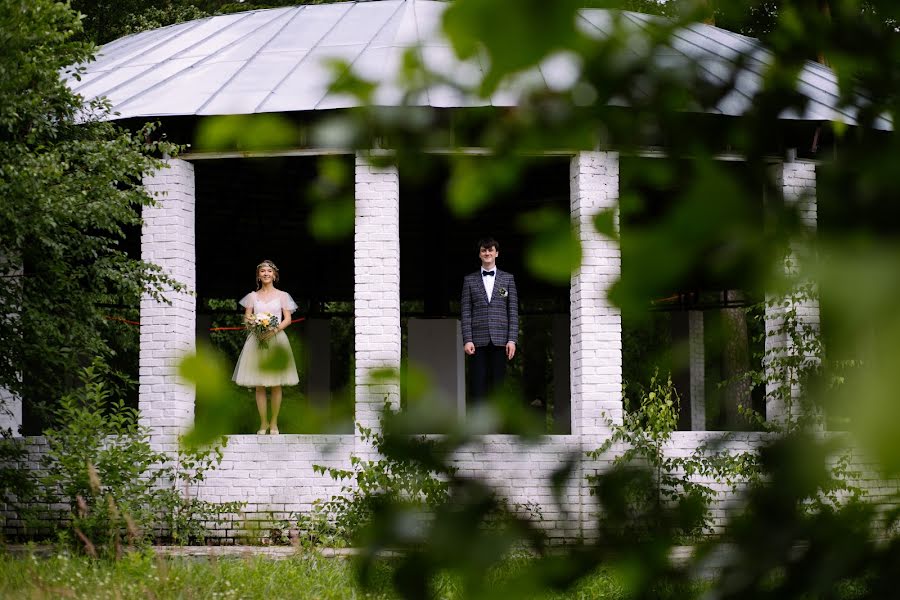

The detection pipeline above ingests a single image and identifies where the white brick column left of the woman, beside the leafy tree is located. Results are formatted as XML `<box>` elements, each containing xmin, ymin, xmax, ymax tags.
<box><xmin>138</xmin><ymin>159</ymin><xmax>197</xmax><ymax>451</ymax></box>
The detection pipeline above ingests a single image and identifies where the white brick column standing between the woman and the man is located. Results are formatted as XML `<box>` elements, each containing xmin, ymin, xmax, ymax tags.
<box><xmin>353</xmin><ymin>154</ymin><xmax>400</xmax><ymax>436</ymax></box>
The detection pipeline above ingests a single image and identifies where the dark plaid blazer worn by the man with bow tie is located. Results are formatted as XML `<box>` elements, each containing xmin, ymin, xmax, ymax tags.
<box><xmin>460</xmin><ymin>269</ymin><xmax>519</xmax><ymax>347</ymax></box>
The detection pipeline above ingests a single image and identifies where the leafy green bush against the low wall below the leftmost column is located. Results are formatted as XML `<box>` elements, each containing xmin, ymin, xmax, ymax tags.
<box><xmin>39</xmin><ymin>360</ymin><xmax>241</xmax><ymax>556</ymax></box>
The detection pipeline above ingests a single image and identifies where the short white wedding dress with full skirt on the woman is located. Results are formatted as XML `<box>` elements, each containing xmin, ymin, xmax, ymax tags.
<box><xmin>231</xmin><ymin>290</ymin><xmax>300</xmax><ymax>387</ymax></box>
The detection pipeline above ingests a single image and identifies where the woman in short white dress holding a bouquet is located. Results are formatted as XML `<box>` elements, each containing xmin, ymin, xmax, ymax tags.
<box><xmin>232</xmin><ymin>260</ymin><xmax>300</xmax><ymax>435</ymax></box>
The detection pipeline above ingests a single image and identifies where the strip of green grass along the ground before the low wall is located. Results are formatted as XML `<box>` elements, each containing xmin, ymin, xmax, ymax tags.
<box><xmin>0</xmin><ymin>554</ymin><xmax>697</xmax><ymax>600</ymax></box>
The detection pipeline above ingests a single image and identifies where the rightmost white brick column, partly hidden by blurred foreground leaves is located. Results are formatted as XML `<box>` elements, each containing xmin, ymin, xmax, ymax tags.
<box><xmin>765</xmin><ymin>162</ymin><xmax>819</xmax><ymax>423</ymax></box>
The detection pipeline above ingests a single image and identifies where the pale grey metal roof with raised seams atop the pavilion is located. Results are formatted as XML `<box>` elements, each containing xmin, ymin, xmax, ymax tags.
<box><xmin>69</xmin><ymin>0</ymin><xmax>891</xmax><ymax>129</ymax></box>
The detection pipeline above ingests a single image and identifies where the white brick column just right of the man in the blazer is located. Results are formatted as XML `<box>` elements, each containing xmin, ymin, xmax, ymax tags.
<box><xmin>570</xmin><ymin>152</ymin><xmax>622</xmax><ymax>438</ymax></box>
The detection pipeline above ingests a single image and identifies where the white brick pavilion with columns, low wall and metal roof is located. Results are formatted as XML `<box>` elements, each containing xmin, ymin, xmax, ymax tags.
<box><xmin>5</xmin><ymin>0</ymin><xmax>890</xmax><ymax>538</ymax></box>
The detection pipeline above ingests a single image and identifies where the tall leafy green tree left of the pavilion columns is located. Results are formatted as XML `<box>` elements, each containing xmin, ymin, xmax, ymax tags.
<box><xmin>0</xmin><ymin>0</ymin><xmax>180</xmax><ymax>432</ymax></box>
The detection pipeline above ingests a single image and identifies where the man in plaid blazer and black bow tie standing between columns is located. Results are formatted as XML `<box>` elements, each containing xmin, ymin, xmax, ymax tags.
<box><xmin>460</xmin><ymin>237</ymin><xmax>519</xmax><ymax>403</ymax></box>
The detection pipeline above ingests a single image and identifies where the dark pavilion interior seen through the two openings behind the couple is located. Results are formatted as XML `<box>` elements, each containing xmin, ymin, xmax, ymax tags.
<box><xmin>194</xmin><ymin>155</ymin><xmax>570</xmax><ymax>433</ymax></box>
